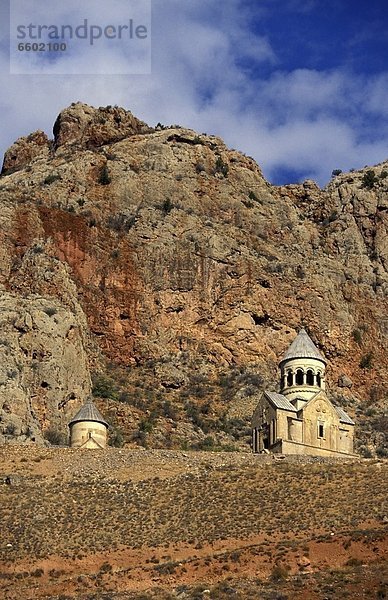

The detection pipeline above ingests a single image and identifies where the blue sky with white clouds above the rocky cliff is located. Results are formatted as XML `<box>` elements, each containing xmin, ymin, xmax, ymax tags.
<box><xmin>0</xmin><ymin>0</ymin><xmax>388</xmax><ymax>185</ymax></box>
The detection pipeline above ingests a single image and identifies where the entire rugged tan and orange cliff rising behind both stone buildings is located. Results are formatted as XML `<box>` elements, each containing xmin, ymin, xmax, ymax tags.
<box><xmin>0</xmin><ymin>103</ymin><xmax>388</xmax><ymax>452</ymax></box>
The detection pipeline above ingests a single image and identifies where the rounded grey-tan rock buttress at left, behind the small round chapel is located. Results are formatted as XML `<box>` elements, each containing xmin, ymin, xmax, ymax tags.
<box><xmin>0</xmin><ymin>292</ymin><xmax>90</xmax><ymax>443</ymax></box>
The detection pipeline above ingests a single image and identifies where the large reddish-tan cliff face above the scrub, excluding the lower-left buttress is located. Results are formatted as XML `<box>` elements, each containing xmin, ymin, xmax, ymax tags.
<box><xmin>0</xmin><ymin>103</ymin><xmax>388</xmax><ymax>450</ymax></box>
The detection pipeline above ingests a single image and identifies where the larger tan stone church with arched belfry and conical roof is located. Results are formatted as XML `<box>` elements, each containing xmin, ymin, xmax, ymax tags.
<box><xmin>252</xmin><ymin>329</ymin><xmax>354</xmax><ymax>456</ymax></box>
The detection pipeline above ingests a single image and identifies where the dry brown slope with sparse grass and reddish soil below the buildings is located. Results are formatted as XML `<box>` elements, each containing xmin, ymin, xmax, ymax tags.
<box><xmin>0</xmin><ymin>447</ymin><xmax>388</xmax><ymax>600</ymax></box>
